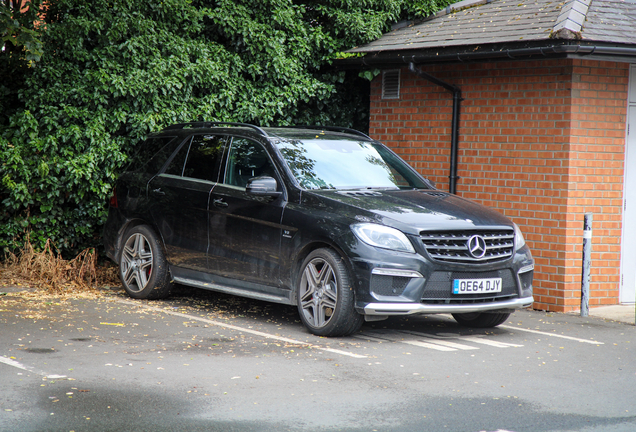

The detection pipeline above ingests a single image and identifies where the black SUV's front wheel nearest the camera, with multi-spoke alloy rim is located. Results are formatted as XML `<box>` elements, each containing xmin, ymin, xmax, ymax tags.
<box><xmin>298</xmin><ymin>248</ymin><xmax>364</xmax><ymax>336</ymax></box>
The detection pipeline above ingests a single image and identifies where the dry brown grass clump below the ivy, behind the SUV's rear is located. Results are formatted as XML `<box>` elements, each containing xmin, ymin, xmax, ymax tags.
<box><xmin>0</xmin><ymin>236</ymin><xmax>119</xmax><ymax>294</ymax></box>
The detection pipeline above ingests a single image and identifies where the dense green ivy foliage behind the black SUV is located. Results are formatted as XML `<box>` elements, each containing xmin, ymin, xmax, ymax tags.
<box><xmin>0</xmin><ymin>0</ymin><xmax>458</xmax><ymax>254</ymax></box>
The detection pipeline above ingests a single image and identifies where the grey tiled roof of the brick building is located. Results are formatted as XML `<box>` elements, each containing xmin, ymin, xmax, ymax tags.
<box><xmin>349</xmin><ymin>0</ymin><xmax>636</xmax><ymax>53</ymax></box>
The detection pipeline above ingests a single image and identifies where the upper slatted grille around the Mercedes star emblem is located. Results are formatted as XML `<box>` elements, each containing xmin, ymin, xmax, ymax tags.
<box><xmin>420</xmin><ymin>229</ymin><xmax>515</xmax><ymax>263</ymax></box>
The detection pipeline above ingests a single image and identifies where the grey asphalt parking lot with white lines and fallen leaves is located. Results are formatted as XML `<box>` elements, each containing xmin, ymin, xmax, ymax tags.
<box><xmin>0</xmin><ymin>287</ymin><xmax>636</xmax><ymax>432</ymax></box>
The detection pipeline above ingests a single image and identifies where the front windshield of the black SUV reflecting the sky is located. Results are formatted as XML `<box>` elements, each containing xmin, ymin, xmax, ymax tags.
<box><xmin>277</xmin><ymin>136</ymin><xmax>430</xmax><ymax>189</ymax></box>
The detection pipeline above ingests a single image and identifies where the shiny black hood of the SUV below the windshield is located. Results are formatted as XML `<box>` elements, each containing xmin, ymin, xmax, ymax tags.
<box><xmin>304</xmin><ymin>190</ymin><xmax>513</xmax><ymax>235</ymax></box>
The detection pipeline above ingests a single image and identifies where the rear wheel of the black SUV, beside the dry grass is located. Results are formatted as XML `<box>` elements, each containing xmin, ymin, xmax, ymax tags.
<box><xmin>119</xmin><ymin>225</ymin><xmax>172</xmax><ymax>300</ymax></box>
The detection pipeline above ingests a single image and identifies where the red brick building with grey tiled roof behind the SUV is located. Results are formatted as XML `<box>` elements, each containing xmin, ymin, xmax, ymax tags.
<box><xmin>340</xmin><ymin>0</ymin><xmax>636</xmax><ymax>311</ymax></box>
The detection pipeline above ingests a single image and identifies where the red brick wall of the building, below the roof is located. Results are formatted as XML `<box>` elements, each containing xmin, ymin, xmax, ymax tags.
<box><xmin>370</xmin><ymin>59</ymin><xmax>629</xmax><ymax>311</ymax></box>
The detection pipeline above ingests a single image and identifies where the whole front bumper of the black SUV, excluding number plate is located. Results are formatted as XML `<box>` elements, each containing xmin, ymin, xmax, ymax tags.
<box><xmin>352</xmin><ymin>240</ymin><xmax>534</xmax><ymax>317</ymax></box>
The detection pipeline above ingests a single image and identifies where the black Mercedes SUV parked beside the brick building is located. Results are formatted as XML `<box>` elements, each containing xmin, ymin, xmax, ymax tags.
<box><xmin>104</xmin><ymin>122</ymin><xmax>534</xmax><ymax>336</ymax></box>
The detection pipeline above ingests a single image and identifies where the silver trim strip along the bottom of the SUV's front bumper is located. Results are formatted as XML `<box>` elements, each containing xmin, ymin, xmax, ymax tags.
<box><xmin>363</xmin><ymin>296</ymin><xmax>534</xmax><ymax>316</ymax></box>
